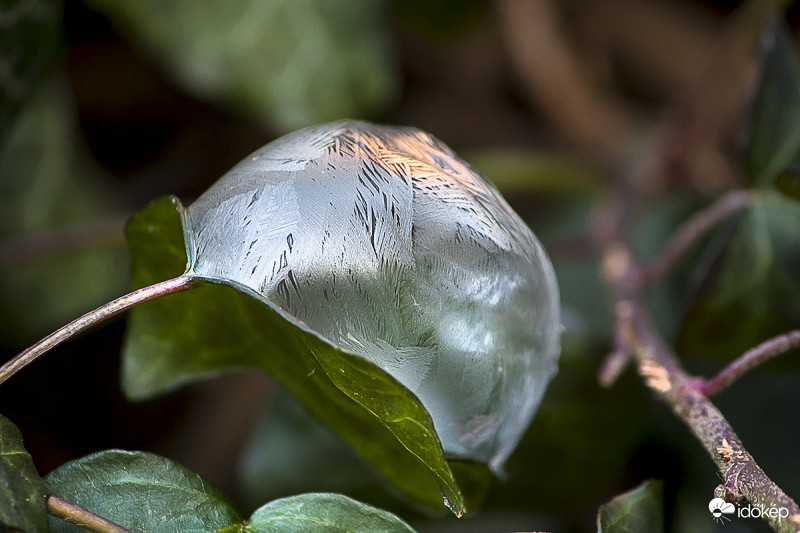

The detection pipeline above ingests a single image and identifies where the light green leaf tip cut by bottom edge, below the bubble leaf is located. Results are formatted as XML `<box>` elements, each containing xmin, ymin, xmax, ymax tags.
<box><xmin>246</xmin><ymin>493</ymin><xmax>414</xmax><ymax>533</ymax></box>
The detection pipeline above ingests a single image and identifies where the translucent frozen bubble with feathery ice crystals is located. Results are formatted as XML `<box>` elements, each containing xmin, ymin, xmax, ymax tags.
<box><xmin>187</xmin><ymin>121</ymin><xmax>560</xmax><ymax>470</ymax></box>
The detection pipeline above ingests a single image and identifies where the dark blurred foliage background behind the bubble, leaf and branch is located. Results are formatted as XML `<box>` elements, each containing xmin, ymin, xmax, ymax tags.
<box><xmin>0</xmin><ymin>0</ymin><xmax>800</xmax><ymax>532</ymax></box>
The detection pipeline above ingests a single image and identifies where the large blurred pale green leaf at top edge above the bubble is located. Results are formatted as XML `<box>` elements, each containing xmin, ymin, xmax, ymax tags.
<box><xmin>89</xmin><ymin>0</ymin><xmax>397</xmax><ymax>130</ymax></box>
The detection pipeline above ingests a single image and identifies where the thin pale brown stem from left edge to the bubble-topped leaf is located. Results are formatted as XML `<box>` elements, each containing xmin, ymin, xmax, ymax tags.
<box><xmin>0</xmin><ymin>275</ymin><xmax>194</xmax><ymax>384</ymax></box>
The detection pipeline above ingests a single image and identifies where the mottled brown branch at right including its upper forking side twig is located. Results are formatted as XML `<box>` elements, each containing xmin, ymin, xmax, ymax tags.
<box><xmin>593</xmin><ymin>0</ymin><xmax>800</xmax><ymax>532</ymax></box>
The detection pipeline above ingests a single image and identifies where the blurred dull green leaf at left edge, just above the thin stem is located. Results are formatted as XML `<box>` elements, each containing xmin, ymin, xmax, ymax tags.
<box><xmin>0</xmin><ymin>80</ymin><xmax>127</xmax><ymax>338</ymax></box>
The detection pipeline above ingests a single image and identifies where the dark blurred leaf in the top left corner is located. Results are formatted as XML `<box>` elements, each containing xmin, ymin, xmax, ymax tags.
<box><xmin>0</xmin><ymin>0</ymin><xmax>62</xmax><ymax>147</ymax></box>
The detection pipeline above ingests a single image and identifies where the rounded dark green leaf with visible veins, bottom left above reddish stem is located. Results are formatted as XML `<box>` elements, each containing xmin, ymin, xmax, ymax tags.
<box><xmin>45</xmin><ymin>450</ymin><xmax>242</xmax><ymax>533</ymax></box>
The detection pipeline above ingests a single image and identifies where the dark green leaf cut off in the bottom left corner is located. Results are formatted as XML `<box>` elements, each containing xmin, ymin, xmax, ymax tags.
<box><xmin>0</xmin><ymin>415</ymin><xmax>48</xmax><ymax>532</ymax></box>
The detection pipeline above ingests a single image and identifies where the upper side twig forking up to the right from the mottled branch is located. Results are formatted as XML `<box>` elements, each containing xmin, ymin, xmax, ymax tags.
<box><xmin>643</xmin><ymin>190</ymin><xmax>756</xmax><ymax>284</ymax></box>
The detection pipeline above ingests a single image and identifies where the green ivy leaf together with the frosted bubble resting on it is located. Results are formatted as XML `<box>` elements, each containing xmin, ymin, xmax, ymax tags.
<box><xmin>125</xmin><ymin>120</ymin><xmax>561</xmax><ymax>513</ymax></box>
